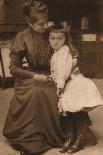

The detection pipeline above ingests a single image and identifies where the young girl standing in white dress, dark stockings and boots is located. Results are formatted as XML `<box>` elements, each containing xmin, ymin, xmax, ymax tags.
<box><xmin>49</xmin><ymin>24</ymin><xmax>103</xmax><ymax>154</ymax></box>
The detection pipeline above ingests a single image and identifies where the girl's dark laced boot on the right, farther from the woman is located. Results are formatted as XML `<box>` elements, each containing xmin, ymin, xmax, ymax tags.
<box><xmin>67</xmin><ymin>135</ymin><xmax>83</xmax><ymax>154</ymax></box>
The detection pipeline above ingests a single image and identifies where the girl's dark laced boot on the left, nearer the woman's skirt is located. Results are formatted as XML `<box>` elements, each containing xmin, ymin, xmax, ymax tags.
<box><xmin>59</xmin><ymin>136</ymin><xmax>74</xmax><ymax>153</ymax></box>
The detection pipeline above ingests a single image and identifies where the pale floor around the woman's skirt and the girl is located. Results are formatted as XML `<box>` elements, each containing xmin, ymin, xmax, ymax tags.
<box><xmin>0</xmin><ymin>79</ymin><xmax>103</xmax><ymax>155</ymax></box>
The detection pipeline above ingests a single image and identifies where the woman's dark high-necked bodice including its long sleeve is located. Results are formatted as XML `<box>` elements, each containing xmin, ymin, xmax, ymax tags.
<box><xmin>10</xmin><ymin>28</ymin><xmax>51</xmax><ymax>78</ymax></box>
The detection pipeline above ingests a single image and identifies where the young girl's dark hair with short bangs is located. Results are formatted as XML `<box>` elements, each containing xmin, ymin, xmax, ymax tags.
<box><xmin>49</xmin><ymin>22</ymin><xmax>69</xmax><ymax>44</ymax></box>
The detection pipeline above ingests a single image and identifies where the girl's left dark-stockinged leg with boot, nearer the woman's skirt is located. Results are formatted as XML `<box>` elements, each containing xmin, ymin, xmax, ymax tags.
<box><xmin>60</xmin><ymin>113</ymin><xmax>75</xmax><ymax>153</ymax></box>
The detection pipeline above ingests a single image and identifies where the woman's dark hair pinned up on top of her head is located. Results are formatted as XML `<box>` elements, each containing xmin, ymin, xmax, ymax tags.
<box><xmin>23</xmin><ymin>0</ymin><xmax>48</xmax><ymax>22</ymax></box>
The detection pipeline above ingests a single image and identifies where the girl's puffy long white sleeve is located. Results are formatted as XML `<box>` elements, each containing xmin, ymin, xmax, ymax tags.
<box><xmin>51</xmin><ymin>46</ymin><xmax>72</xmax><ymax>88</ymax></box>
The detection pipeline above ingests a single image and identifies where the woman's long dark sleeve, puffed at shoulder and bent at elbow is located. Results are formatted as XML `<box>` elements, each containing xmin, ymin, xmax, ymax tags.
<box><xmin>10</xmin><ymin>33</ymin><xmax>34</xmax><ymax>79</ymax></box>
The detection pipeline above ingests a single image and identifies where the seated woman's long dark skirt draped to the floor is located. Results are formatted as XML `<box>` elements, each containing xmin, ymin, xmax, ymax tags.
<box><xmin>3</xmin><ymin>79</ymin><xmax>65</xmax><ymax>153</ymax></box>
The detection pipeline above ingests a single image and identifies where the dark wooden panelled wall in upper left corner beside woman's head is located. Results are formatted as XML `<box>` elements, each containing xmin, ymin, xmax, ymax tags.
<box><xmin>0</xmin><ymin>0</ymin><xmax>25</xmax><ymax>32</ymax></box>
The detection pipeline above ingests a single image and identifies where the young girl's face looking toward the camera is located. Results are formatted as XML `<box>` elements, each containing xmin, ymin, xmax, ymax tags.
<box><xmin>49</xmin><ymin>32</ymin><xmax>66</xmax><ymax>51</ymax></box>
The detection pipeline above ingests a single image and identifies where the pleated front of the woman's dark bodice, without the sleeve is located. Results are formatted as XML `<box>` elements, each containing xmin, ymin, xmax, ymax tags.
<box><xmin>27</xmin><ymin>32</ymin><xmax>51</xmax><ymax>70</ymax></box>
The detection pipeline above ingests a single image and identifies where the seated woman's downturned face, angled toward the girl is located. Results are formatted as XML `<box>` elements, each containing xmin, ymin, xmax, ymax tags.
<box><xmin>29</xmin><ymin>16</ymin><xmax>48</xmax><ymax>33</ymax></box>
